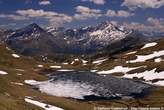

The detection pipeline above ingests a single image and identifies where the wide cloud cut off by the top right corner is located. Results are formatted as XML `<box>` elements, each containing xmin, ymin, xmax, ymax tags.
<box><xmin>122</xmin><ymin>0</ymin><xmax>164</xmax><ymax>9</ymax></box>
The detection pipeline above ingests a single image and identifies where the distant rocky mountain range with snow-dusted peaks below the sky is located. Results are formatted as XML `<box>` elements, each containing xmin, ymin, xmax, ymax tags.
<box><xmin>0</xmin><ymin>22</ymin><xmax>159</xmax><ymax>61</ymax></box>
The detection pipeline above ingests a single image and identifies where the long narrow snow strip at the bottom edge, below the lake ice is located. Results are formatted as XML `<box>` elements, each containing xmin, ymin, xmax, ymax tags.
<box><xmin>24</xmin><ymin>98</ymin><xmax>64</xmax><ymax>110</ymax></box>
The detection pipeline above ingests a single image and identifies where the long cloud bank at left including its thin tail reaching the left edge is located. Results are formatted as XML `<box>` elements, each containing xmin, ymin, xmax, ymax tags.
<box><xmin>0</xmin><ymin>9</ymin><xmax>73</xmax><ymax>27</ymax></box>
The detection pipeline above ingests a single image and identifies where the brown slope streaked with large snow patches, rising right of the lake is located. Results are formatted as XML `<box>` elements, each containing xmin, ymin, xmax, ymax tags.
<box><xmin>93</xmin><ymin>39</ymin><xmax>164</xmax><ymax>85</ymax></box>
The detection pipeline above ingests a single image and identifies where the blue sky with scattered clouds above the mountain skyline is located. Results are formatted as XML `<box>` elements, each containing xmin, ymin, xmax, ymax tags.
<box><xmin>0</xmin><ymin>0</ymin><xmax>164</xmax><ymax>32</ymax></box>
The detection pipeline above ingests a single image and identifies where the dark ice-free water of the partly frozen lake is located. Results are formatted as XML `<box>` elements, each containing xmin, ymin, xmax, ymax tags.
<box><xmin>50</xmin><ymin>71</ymin><xmax>151</xmax><ymax>99</ymax></box>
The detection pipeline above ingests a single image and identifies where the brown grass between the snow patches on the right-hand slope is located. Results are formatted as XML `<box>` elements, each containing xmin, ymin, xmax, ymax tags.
<box><xmin>95</xmin><ymin>40</ymin><xmax>164</xmax><ymax>74</ymax></box>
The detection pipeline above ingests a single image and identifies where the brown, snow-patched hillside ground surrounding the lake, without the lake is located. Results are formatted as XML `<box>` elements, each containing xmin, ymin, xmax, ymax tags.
<box><xmin>0</xmin><ymin>37</ymin><xmax>164</xmax><ymax>110</ymax></box>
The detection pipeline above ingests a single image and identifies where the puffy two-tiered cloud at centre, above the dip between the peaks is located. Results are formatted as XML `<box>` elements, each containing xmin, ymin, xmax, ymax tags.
<box><xmin>74</xmin><ymin>6</ymin><xmax>102</xmax><ymax>20</ymax></box>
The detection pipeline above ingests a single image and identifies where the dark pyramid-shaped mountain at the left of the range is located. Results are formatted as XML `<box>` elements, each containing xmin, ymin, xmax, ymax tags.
<box><xmin>6</xmin><ymin>24</ymin><xmax>67</xmax><ymax>56</ymax></box>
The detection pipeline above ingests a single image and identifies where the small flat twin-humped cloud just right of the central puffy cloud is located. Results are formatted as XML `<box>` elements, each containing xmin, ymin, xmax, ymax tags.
<box><xmin>106</xmin><ymin>10</ymin><xmax>134</xmax><ymax>17</ymax></box>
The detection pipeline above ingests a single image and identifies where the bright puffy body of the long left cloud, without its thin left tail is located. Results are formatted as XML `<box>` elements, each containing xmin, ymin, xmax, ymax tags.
<box><xmin>16</xmin><ymin>9</ymin><xmax>72</xmax><ymax>27</ymax></box>
